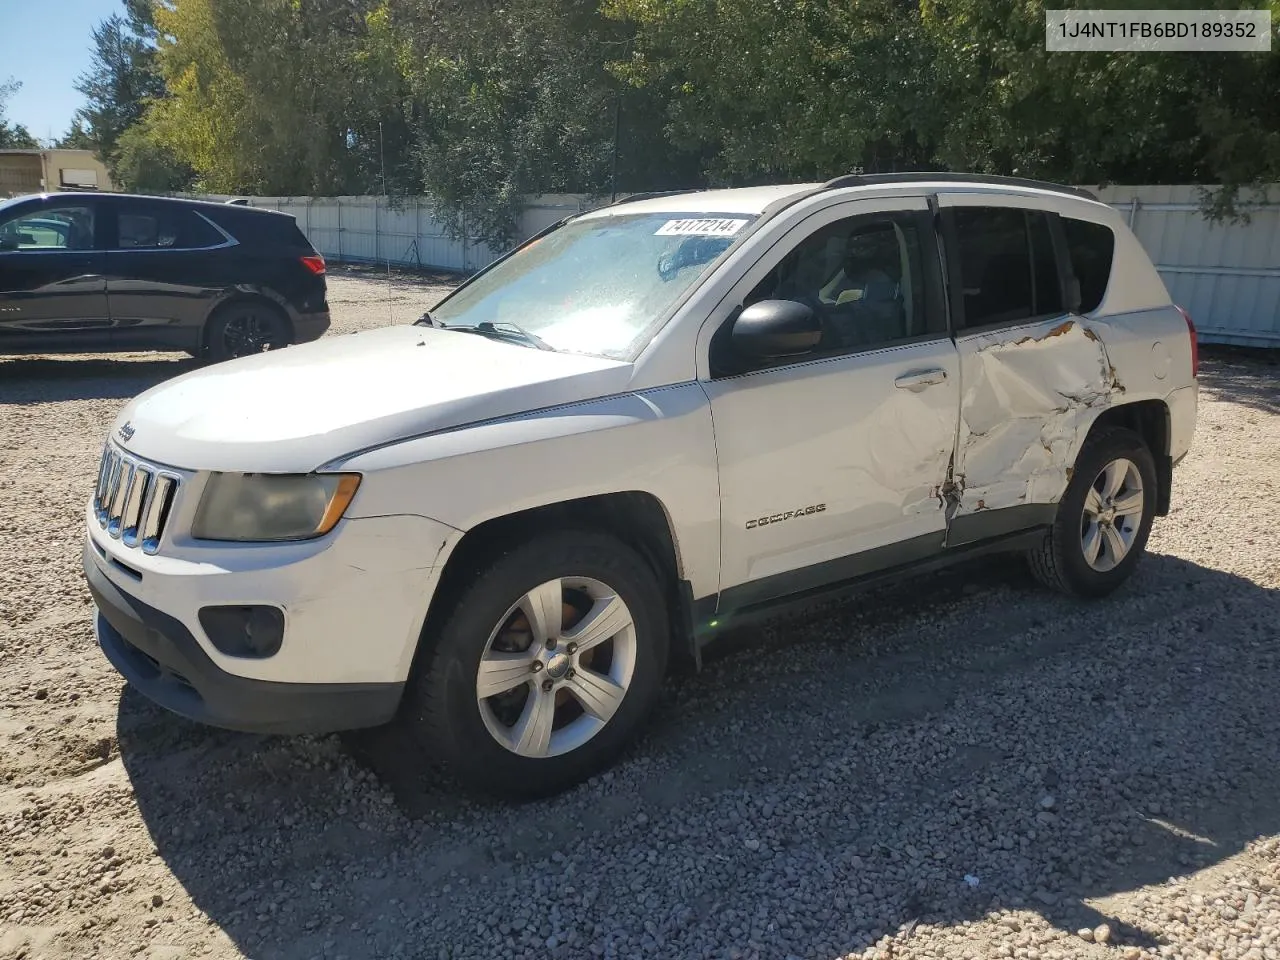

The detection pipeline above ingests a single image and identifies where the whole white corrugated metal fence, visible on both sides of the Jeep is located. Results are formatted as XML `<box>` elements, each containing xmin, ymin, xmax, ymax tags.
<box><xmin>212</xmin><ymin>186</ymin><xmax>1280</xmax><ymax>347</ymax></box>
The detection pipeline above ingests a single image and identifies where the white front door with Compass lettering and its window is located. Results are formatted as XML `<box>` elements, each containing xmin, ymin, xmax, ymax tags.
<box><xmin>704</xmin><ymin>197</ymin><xmax>960</xmax><ymax>613</ymax></box>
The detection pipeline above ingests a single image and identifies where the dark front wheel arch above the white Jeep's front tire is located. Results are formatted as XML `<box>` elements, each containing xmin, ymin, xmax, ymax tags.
<box><xmin>413</xmin><ymin>490</ymin><xmax>696</xmax><ymax>686</ymax></box>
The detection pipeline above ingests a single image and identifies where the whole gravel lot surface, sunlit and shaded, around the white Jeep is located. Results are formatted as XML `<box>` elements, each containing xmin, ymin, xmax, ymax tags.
<box><xmin>0</xmin><ymin>271</ymin><xmax>1280</xmax><ymax>960</ymax></box>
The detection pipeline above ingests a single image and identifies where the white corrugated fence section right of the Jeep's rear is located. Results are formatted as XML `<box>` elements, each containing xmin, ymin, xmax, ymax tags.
<box><xmin>1094</xmin><ymin>186</ymin><xmax>1280</xmax><ymax>347</ymax></box>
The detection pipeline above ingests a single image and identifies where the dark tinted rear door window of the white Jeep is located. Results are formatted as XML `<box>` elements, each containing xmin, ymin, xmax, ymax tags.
<box><xmin>954</xmin><ymin>207</ymin><xmax>1062</xmax><ymax>328</ymax></box>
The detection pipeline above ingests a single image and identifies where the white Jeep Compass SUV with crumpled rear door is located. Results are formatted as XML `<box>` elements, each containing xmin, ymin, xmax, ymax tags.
<box><xmin>83</xmin><ymin>174</ymin><xmax>1197</xmax><ymax>795</ymax></box>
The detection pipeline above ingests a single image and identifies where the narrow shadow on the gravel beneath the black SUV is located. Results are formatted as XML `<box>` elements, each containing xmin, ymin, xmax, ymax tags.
<box><xmin>0</xmin><ymin>355</ymin><xmax>200</xmax><ymax>404</ymax></box>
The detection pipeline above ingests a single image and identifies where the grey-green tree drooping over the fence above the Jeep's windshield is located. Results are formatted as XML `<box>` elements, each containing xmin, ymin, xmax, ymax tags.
<box><xmin>389</xmin><ymin>0</ymin><xmax>700</xmax><ymax>246</ymax></box>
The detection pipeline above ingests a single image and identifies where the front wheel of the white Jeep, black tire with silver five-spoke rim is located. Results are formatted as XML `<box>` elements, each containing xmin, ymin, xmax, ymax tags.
<box><xmin>396</xmin><ymin>532</ymin><xmax>669</xmax><ymax>797</ymax></box>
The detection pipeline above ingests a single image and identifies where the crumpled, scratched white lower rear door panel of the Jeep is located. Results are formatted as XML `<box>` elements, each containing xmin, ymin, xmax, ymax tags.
<box><xmin>954</xmin><ymin>320</ymin><xmax>1124</xmax><ymax>515</ymax></box>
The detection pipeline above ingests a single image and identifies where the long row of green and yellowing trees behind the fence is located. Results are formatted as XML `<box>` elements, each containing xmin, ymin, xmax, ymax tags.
<box><xmin>74</xmin><ymin>0</ymin><xmax>1280</xmax><ymax>243</ymax></box>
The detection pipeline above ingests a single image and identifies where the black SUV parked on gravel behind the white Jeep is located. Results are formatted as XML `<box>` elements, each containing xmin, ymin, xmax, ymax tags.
<box><xmin>0</xmin><ymin>193</ymin><xmax>329</xmax><ymax>361</ymax></box>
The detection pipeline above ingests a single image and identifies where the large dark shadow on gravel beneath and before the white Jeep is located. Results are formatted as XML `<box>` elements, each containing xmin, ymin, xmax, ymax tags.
<box><xmin>118</xmin><ymin>556</ymin><xmax>1280</xmax><ymax>960</ymax></box>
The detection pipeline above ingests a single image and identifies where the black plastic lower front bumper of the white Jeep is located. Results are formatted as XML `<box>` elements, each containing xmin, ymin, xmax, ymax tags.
<box><xmin>83</xmin><ymin>543</ymin><xmax>404</xmax><ymax>733</ymax></box>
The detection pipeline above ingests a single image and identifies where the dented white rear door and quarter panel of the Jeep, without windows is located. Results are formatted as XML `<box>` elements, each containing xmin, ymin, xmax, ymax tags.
<box><xmin>937</xmin><ymin>191</ymin><xmax>1194</xmax><ymax>535</ymax></box>
